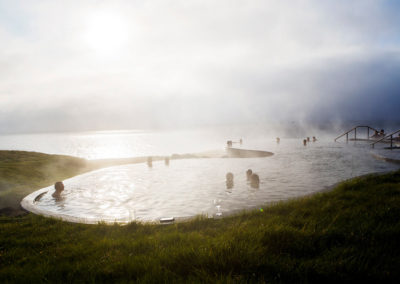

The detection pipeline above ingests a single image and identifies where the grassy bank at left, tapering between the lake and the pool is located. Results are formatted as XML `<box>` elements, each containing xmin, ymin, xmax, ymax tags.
<box><xmin>0</xmin><ymin>150</ymin><xmax>220</xmax><ymax>216</ymax></box>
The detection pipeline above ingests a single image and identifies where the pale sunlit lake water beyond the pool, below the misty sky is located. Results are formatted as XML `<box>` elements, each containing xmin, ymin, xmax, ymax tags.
<box><xmin>0</xmin><ymin>122</ymin><xmax>396</xmax><ymax>159</ymax></box>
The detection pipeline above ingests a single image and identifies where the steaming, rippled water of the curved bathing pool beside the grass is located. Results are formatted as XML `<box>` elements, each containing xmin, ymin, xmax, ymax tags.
<box><xmin>21</xmin><ymin>141</ymin><xmax>398</xmax><ymax>223</ymax></box>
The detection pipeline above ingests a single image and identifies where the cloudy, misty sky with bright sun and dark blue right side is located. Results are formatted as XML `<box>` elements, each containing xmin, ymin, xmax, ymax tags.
<box><xmin>0</xmin><ymin>0</ymin><xmax>400</xmax><ymax>133</ymax></box>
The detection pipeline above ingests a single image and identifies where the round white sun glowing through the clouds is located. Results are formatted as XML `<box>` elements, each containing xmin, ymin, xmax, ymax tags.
<box><xmin>84</xmin><ymin>11</ymin><xmax>128</xmax><ymax>56</ymax></box>
